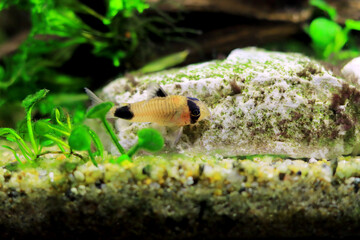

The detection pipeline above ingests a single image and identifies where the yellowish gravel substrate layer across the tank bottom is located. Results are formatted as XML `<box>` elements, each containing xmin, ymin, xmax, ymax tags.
<box><xmin>0</xmin><ymin>150</ymin><xmax>360</xmax><ymax>239</ymax></box>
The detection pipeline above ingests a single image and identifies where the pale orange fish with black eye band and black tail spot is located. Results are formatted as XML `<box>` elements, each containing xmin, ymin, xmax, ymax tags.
<box><xmin>85</xmin><ymin>85</ymin><xmax>210</xmax><ymax>127</ymax></box>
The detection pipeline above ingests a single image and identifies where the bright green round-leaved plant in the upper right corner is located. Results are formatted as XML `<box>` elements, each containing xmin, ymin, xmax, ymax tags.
<box><xmin>306</xmin><ymin>0</ymin><xmax>360</xmax><ymax>59</ymax></box>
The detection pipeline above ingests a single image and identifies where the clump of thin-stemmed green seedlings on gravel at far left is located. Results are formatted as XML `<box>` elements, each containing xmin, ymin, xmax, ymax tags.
<box><xmin>0</xmin><ymin>89</ymin><xmax>104</xmax><ymax>165</ymax></box>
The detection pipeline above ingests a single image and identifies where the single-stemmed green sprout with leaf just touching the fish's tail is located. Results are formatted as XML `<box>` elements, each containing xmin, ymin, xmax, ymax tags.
<box><xmin>87</xmin><ymin>102</ymin><xmax>125</xmax><ymax>154</ymax></box>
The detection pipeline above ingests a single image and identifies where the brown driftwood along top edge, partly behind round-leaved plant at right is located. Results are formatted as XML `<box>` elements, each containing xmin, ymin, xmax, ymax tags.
<box><xmin>148</xmin><ymin>0</ymin><xmax>360</xmax><ymax>23</ymax></box>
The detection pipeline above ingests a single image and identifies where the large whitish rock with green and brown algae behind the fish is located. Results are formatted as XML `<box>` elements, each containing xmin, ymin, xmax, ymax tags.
<box><xmin>103</xmin><ymin>48</ymin><xmax>360</xmax><ymax>158</ymax></box>
